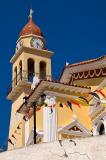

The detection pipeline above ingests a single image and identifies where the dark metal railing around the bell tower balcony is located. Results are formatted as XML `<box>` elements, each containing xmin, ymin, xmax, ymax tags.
<box><xmin>7</xmin><ymin>71</ymin><xmax>51</xmax><ymax>96</ymax></box>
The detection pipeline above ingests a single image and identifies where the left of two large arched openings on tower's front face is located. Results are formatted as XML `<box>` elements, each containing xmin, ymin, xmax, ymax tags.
<box><xmin>28</xmin><ymin>58</ymin><xmax>34</xmax><ymax>82</ymax></box>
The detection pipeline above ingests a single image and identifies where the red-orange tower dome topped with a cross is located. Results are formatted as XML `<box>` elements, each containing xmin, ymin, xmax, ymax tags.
<box><xmin>20</xmin><ymin>10</ymin><xmax>43</xmax><ymax>36</ymax></box>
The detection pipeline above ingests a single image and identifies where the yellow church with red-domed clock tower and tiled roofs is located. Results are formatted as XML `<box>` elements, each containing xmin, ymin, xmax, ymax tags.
<box><xmin>7</xmin><ymin>9</ymin><xmax>106</xmax><ymax>150</ymax></box>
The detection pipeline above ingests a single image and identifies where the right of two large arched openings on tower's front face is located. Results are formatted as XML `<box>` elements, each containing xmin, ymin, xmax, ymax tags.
<box><xmin>40</xmin><ymin>61</ymin><xmax>46</xmax><ymax>79</ymax></box>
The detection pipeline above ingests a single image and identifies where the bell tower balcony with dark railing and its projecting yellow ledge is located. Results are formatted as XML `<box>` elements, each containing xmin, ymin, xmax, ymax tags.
<box><xmin>7</xmin><ymin>71</ymin><xmax>51</xmax><ymax>100</ymax></box>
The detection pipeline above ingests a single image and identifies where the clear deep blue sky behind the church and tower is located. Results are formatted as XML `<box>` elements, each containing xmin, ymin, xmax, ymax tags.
<box><xmin>0</xmin><ymin>0</ymin><xmax>106</xmax><ymax>148</ymax></box>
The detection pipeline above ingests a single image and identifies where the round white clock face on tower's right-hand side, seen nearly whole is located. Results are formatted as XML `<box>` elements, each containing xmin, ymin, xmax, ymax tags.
<box><xmin>31</xmin><ymin>38</ymin><xmax>44</xmax><ymax>49</ymax></box>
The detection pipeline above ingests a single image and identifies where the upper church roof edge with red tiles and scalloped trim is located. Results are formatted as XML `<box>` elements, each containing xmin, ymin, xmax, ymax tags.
<box><xmin>60</xmin><ymin>55</ymin><xmax>106</xmax><ymax>84</ymax></box>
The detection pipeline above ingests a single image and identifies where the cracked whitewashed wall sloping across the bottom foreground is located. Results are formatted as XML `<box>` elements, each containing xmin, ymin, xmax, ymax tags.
<box><xmin>0</xmin><ymin>136</ymin><xmax>106</xmax><ymax>160</ymax></box>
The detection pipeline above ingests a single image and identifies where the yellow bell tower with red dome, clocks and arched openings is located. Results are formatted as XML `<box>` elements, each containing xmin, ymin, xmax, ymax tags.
<box><xmin>7</xmin><ymin>9</ymin><xmax>53</xmax><ymax>149</ymax></box>
